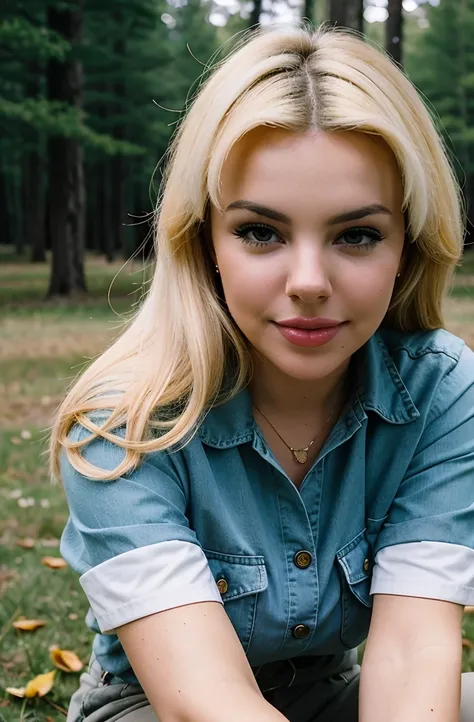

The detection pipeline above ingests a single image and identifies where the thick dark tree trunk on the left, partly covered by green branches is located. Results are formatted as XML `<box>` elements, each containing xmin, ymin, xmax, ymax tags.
<box><xmin>48</xmin><ymin>0</ymin><xmax>86</xmax><ymax>296</ymax></box>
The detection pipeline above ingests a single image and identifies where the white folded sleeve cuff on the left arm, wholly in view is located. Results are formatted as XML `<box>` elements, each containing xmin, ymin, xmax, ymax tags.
<box><xmin>79</xmin><ymin>541</ymin><xmax>222</xmax><ymax>634</ymax></box>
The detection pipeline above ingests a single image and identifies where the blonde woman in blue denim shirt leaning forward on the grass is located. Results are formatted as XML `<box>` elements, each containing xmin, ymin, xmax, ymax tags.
<box><xmin>52</xmin><ymin>22</ymin><xmax>474</xmax><ymax>722</ymax></box>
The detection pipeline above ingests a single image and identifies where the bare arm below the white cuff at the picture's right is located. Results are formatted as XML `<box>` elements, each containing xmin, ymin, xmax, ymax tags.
<box><xmin>359</xmin><ymin>594</ymin><xmax>463</xmax><ymax>722</ymax></box>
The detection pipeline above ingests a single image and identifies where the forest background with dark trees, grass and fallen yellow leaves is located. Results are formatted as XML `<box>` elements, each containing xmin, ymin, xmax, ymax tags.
<box><xmin>0</xmin><ymin>0</ymin><xmax>474</xmax><ymax>722</ymax></box>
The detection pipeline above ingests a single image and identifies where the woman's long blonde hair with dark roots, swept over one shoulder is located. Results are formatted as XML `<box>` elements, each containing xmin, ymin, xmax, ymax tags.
<box><xmin>51</xmin><ymin>27</ymin><xmax>463</xmax><ymax>480</ymax></box>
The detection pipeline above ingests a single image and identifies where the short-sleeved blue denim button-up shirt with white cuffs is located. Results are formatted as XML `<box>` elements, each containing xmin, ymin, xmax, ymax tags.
<box><xmin>61</xmin><ymin>329</ymin><xmax>474</xmax><ymax>681</ymax></box>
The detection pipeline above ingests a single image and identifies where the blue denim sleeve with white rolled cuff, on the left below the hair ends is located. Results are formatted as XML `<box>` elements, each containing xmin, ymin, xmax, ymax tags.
<box><xmin>61</xmin><ymin>420</ymin><xmax>222</xmax><ymax>634</ymax></box>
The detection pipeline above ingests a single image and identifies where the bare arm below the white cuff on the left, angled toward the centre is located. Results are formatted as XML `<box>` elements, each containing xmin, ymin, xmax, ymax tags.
<box><xmin>117</xmin><ymin>602</ymin><xmax>286</xmax><ymax>722</ymax></box>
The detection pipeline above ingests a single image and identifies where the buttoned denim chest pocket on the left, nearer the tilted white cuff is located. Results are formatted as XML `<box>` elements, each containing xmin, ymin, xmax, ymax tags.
<box><xmin>204</xmin><ymin>549</ymin><xmax>268</xmax><ymax>652</ymax></box>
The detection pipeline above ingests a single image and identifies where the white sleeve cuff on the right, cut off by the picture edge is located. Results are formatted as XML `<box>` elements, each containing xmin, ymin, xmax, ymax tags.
<box><xmin>370</xmin><ymin>541</ymin><xmax>474</xmax><ymax>605</ymax></box>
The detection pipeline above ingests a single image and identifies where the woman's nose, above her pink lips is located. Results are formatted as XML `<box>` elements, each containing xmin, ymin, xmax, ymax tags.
<box><xmin>286</xmin><ymin>242</ymin><xmax>332</xmax><ymax>303</ymax></box>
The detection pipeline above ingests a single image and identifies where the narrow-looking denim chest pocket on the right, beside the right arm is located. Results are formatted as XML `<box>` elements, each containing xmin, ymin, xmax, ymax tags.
<box><xmin>336</xmin><ymin>529</ymin><xmax>372</xmax><ymax>649</ymax></box>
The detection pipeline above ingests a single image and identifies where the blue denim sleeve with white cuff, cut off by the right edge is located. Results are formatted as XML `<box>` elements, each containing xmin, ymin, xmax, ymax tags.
<box><xmin>371</xmin><ymin>347</ymin><xmax>474</xmax><ymax>605</ymax></box>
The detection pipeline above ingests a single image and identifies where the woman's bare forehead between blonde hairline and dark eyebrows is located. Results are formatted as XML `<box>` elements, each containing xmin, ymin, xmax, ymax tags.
<box><xmin>220</xmin><ymin>127</ymin><xmax>403</xmax><ymax>215</ymax></box>
